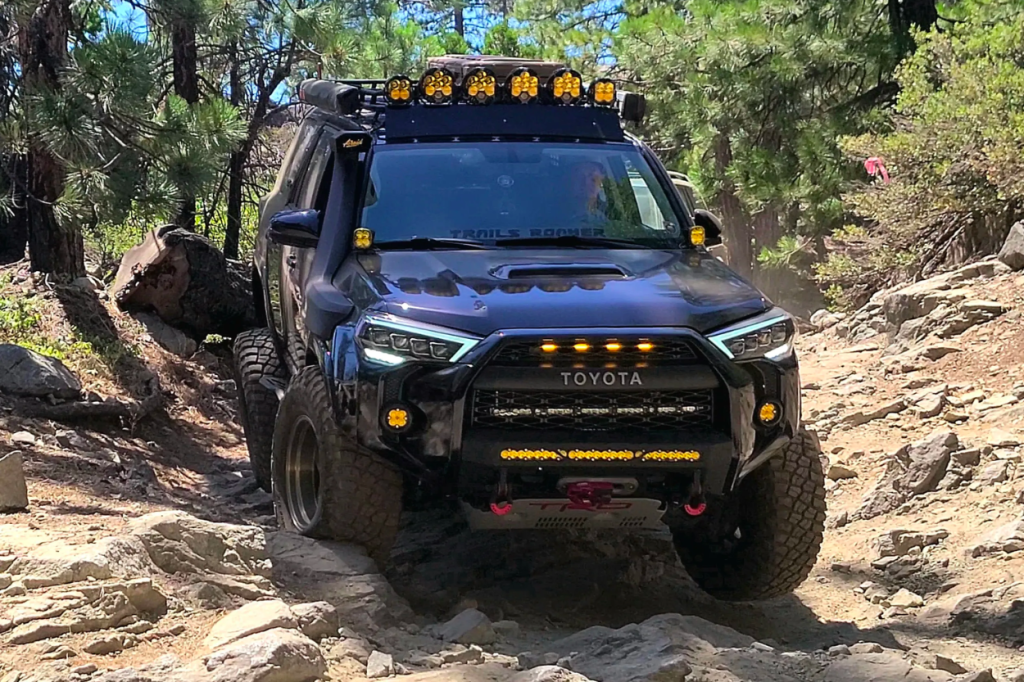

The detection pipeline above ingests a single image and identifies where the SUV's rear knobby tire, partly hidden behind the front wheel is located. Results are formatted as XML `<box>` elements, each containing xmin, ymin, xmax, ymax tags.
<box><xmin>233</xmin><ymin>329</ymin><xmax>288</xmax><ymax>493</ymax></box>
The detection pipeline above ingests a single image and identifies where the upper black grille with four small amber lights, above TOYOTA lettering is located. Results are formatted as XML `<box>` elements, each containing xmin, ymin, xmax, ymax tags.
<box><xmin>487</xmin><ymin>336</ymin><xmax>697</xmax><ymax>367</ymax></box>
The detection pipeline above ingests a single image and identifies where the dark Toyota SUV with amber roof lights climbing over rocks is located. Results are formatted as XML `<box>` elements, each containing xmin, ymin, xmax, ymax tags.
<box><xmin>236</xmin><ymin>57</ymin><xmax>825</xmax><ymax>599</ymax></box>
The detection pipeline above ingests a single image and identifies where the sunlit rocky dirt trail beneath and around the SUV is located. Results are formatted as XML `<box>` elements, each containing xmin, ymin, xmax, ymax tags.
<box><xmin>0</xmin><ymin>246</ymin><xmax>1024</xmax><ymax>682</ymax></box>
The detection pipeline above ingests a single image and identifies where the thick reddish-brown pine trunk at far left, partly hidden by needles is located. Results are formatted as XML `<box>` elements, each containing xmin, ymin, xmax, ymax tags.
<box><xmin>18</xmin><ymin>0</ymin><xmax>85</xmax><ymax>278</ymax></box>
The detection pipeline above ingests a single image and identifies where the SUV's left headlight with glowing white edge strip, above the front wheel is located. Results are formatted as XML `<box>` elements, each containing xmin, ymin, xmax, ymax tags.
<box><xmin>358</xmin><ymin>315</ymin><xmax>480</xmax><ymax>365</ymax></box>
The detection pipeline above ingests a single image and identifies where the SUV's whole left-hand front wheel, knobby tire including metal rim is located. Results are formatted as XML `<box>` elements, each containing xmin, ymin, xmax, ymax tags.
<box><xmin>273</xmin><ymin>367</ymin><xmax>402</xmax><ymax>565</ymax></box>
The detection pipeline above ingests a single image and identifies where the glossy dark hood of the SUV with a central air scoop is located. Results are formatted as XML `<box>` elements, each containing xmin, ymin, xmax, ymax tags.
<box><xmin>358</xmin><ymin>248</ymin><xmax>771</xmax><ymax>336</ymax></box>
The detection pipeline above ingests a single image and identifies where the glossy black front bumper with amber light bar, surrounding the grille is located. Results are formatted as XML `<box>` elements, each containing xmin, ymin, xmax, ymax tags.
<box><xmin>329</xmin><ymin>328</ymin><xmax>800</xmax><ymax>495</ymax></box>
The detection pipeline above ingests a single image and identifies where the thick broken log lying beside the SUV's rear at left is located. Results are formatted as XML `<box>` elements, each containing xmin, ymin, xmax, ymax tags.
<box><xmin>112</xmin><ymin>225</ymin><xmax>256</xmax><ymax>342</ymax></box>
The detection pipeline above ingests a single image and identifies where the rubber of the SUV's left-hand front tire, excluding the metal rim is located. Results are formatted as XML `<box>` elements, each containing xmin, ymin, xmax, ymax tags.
<box><xmin>273</xmin><ymin>367</ymin><xmax>402</xmax><ymax>566</ymax></box>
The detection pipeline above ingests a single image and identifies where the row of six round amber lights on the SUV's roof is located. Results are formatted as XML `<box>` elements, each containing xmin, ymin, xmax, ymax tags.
<box><xmin>384</xmin><ymin>67</ymin><xmax>615</xmax><ymax>106</ymax></box>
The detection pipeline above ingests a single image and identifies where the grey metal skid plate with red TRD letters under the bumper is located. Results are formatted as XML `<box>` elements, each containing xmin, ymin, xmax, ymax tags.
<box><xmin>463</xmin><ymin>498</ymin><xmax>665</xmax><ymax>530</ymax></box>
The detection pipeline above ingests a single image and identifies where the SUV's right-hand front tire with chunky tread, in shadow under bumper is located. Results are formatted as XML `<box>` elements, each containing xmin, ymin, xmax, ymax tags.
<box><xmin>673</xmin><ymin>430</ymin><xmax>825</xmax><ymax>601</ymax></box>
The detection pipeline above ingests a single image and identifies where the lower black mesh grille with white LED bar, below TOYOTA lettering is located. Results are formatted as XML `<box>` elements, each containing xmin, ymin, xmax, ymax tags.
<box><xmin>472</xmin><ymin>390</ymin><xmax>714</xmax><ymax>431</ymax></box>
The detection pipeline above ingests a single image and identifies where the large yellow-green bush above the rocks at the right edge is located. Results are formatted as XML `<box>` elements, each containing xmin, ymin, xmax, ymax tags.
<box><xmin>819</xmin><ymin>9</ymin><xmax>1024</xmax><ymax>301</ymax></box>
